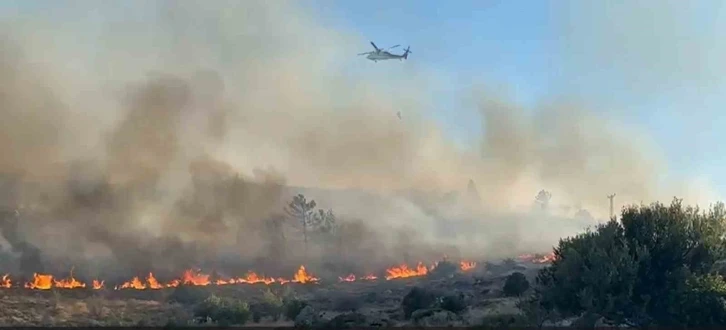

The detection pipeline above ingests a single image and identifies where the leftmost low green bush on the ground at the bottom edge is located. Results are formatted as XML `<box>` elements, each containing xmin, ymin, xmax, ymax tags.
<box><xmin>194</xmin><ymin>295</ymin><xmax>251</xmax><ymax>326</ymax></box>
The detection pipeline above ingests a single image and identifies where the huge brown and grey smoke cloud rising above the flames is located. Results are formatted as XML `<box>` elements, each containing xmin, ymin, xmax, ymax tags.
<box><xmin>0</xmin><ymin>1</ymin><xmax>720</xmax><ymax>278</ymax></box>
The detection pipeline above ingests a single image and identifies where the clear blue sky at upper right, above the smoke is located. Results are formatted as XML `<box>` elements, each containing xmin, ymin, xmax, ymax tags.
<box><xmin>306</xmin><ymin>0</ymin><xmax>726</xmax><ymax>196</ymax></box>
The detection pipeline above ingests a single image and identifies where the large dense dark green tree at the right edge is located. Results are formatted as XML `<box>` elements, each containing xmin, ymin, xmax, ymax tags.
<box><xmin>536</xmin><ymin>199</ymin><xmax>726</xmax><ymax>327</ymax></box>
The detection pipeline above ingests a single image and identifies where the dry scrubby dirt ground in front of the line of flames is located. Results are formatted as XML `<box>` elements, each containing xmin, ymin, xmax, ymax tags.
<box><xmin>0</xmin><ymin>264</ymin><xmax>541</xmax><ymax>326</ymax></box>
